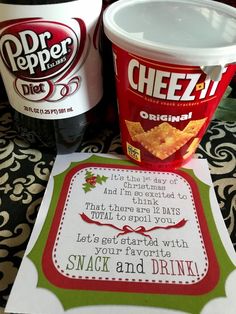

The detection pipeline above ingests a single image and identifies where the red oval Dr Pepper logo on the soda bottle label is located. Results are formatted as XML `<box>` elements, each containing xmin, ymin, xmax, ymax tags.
<box><xmin>0</xmin><ymin>19</ymin><xmax>86</xmax><ymax>81</ymax></box>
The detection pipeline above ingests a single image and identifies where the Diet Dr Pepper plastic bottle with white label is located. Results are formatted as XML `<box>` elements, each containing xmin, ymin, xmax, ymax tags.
<box><xmin>0</xmin><ymin>0</ymin><xmax>105</xmax><ymax>154</ymax></box>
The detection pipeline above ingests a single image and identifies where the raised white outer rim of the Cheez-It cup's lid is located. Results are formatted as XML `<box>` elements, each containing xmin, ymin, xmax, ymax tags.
<box><xmin>103</xmin><ymin>0</ymin><xmax>236</xmax><ymax>66</ymax></box>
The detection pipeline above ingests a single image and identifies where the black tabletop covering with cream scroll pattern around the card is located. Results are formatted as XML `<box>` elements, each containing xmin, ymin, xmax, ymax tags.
<box><xmin>0</xmin><ymin>102</ymin><xmax>236</xmax><ymax>311</ymax></box>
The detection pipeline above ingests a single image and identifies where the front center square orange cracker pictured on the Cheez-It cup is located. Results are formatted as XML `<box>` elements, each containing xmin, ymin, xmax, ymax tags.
<box><xmin>135</xmin><ymin>122</ymin><xmax>192</xmax><ymax>160</ymax></box>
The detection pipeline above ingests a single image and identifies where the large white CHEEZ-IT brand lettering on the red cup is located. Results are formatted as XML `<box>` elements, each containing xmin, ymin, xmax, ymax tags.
<box><xmin>125</xmin><ymin>58</ymin><xmax>226</xmax><ymax>101</ymax></box>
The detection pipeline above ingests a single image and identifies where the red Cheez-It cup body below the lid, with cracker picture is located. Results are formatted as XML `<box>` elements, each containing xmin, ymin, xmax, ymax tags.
<box><xmin>113</xmin><ymin>47</ymin><xmax>235</xmax><ymax>168</ymax></box>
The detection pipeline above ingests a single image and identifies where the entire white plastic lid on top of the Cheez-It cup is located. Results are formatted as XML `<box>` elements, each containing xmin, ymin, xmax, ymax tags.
<box><xmin>104</xmin><ymin>0</ymin><xmax>236</xmax><ymax>67</ymax></box>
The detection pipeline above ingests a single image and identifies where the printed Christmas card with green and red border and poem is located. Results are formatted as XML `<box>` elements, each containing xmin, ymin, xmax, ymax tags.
<box><xmin>6</xmin><ymin>153</ymin><xmax>236</xmax><ymax>314</ymax></box>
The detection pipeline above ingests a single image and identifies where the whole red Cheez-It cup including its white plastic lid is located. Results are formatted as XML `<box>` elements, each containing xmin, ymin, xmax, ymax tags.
<box><xmin>104</xmin><ymin>0</ymin><xmax>236</xmax><ymax>169</ymax></box>
